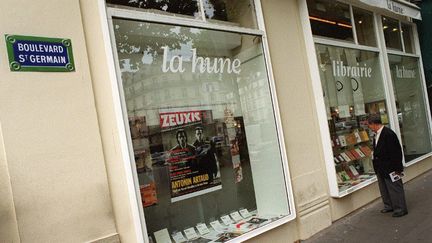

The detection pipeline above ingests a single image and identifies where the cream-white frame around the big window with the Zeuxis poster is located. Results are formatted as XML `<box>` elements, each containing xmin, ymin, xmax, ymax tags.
<box><xmin>98</xmin><ymin>0</ymin><xmax>296</xmax><ymax>242</ymax></box>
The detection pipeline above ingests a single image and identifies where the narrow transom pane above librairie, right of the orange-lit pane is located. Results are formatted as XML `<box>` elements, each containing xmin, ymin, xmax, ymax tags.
<box><xmin>353</xmin><ymin>8</ymin><xmax>377</xmax><ymax>46</ymax></box>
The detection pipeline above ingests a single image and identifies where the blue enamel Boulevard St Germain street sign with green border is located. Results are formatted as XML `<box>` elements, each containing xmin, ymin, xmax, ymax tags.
<box><xmin>5</xmin><ymin>35</ymin><xmax>75</xmax><ymax>72</ymax></box>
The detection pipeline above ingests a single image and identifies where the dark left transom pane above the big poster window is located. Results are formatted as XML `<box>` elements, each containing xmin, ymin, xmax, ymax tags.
<box><xmin>106</xmin><ymin>0</ymin><xmax>199</xmax><ymax>18</ymax></box>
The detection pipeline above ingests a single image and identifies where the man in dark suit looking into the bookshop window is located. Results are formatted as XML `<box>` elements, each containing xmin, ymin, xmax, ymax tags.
<box><xmin>368</xmin><ymin>114</ymin><xmax>408</xmax><ymax>217</ymax></box>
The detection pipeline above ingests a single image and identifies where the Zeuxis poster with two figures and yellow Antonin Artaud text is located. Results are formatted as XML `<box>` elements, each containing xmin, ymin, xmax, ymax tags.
<box><xmin>159</xmin><ymin>110</ymin><xmax>222</xmax><ymax>202</ymax></box>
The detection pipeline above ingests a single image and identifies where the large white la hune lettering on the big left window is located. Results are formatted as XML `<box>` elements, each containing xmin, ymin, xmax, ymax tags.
<box><xmin>162</xmin><ymin>46</ymin><xmax>241</xmax><ymax>74</ymax></box>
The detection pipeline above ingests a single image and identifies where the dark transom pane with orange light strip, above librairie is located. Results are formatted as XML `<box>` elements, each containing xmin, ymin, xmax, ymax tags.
<box><xmin>307</xmin><ymin>0</ymin><xmax>354</xmax><ymax>42</ymax></box>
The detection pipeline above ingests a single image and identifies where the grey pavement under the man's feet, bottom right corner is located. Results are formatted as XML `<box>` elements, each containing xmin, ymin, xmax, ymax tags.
<box><xmin>302</xmin><ymin>171</ymin><xmax>432</xmax><ymax>243</ymax></box>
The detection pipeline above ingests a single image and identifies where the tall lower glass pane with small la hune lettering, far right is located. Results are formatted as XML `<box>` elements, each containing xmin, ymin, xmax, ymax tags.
<box><xmin>389</xmin><ymin>55</ymin><xmax>431</xmax><ymax>162</ymax></box>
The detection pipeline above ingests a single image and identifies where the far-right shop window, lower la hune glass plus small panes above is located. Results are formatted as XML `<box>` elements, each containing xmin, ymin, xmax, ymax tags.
<box><xmin>382</xmin><ymin>16</ymin><xmax>432</xmax><ymax>164</ymax></box>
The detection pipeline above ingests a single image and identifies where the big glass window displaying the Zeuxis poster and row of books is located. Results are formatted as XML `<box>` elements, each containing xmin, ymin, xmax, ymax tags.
<box><xmin>113</xmin><ymin>18</ymin><xmax>293</xmax><ymax>242</ymax></box>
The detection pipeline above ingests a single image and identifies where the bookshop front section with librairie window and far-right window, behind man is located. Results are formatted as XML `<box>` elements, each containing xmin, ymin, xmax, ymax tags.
<box><xmin>307</xmin><ymin>0</ymin><xmax>432</xmax><ymax>197</ymax></box>
